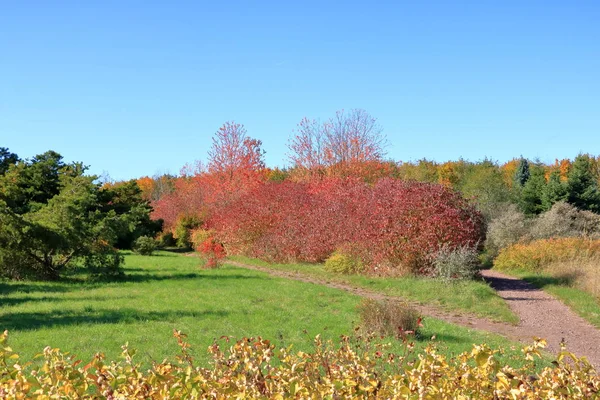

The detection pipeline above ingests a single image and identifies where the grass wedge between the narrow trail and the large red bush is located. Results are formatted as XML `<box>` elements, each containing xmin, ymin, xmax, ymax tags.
<box><xmin>231</xmin><ymin>256</ymin><xmax>519</xmax><ymax>324</ymax></box>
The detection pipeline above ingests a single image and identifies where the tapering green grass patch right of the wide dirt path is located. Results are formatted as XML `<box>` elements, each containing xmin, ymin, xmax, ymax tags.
<box><xmin>492</xmin><ymin>269</ymin><xmax>600</xmax><ymax>328</ymax></box>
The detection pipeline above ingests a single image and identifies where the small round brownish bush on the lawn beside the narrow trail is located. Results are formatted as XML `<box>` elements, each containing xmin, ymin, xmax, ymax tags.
<box><xmin>358</xmin><ymin>299</ymin><xmax>421</xmax><ymax>338</ymax></box>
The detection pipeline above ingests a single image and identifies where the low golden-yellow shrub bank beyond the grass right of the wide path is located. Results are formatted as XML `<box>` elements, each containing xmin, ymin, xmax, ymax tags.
<box><xmin>494</xmin><ymin>238</ymin><xmax>600</xmax><ymax>272</ymax></box>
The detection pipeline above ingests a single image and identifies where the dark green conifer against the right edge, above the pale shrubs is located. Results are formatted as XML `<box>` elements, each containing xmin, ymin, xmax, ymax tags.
<box><xmin>567</xmin><ymin>154</ymin><xmax>600</xmax><ymax>212</ymax></box>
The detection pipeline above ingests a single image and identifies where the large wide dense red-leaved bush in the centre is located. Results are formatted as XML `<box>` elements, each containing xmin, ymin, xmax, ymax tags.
<box><xmin>208</xmin><ymin>178</ymin><xmax>483</xmax><ymax>274</ymax></box>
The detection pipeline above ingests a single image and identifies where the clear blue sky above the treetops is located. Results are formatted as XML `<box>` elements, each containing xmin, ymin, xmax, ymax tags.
<box><xmin>0</xmin><ymin>0</ymin><xmax>600</xmax><ymax>179</ymax></box>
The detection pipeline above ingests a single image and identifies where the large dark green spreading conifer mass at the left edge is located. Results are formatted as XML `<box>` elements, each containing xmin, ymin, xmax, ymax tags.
<box><xmin>0</xmin><ymin>149</ymin><xmax>160</xmax><ymax>279</ymax></box>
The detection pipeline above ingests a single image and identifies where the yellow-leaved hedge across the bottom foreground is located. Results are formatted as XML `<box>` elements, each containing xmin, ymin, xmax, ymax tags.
<box><xmin>0</xmin><ymin>331</ymin><xmax>600</xmax><ymax>399</ymax></box>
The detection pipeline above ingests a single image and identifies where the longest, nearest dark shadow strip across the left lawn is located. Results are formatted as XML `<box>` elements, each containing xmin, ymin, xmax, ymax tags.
<box><xmin>0</xmin><ymin>308</ymin><xmax>229</xmax><ymax>331</ymax></box>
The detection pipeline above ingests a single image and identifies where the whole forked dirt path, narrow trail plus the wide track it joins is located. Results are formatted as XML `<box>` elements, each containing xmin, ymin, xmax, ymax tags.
<box><xmin>227</xmin><ymin>261</ymin><xmax>600</xmax><ymax>366</ymax></box>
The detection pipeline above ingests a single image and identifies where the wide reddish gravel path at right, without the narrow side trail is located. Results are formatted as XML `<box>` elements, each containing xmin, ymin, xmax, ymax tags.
<box><xmin>482</xmin><ymin>270</ymin><xmax>600</xmax><ymax>366</ymax></box>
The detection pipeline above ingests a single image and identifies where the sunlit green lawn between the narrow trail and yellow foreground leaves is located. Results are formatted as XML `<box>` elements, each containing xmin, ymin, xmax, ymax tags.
<box><xmin>0</xmin><ymin>252</ymin><xmax>540</xmax><ymax>365</ymax></box>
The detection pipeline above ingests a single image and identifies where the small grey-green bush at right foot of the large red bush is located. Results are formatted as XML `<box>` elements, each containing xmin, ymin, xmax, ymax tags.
<box><xmin>433</xmin><ymin>246</ymin><xmax>479</xmax><ymax>280</ymax></box>
